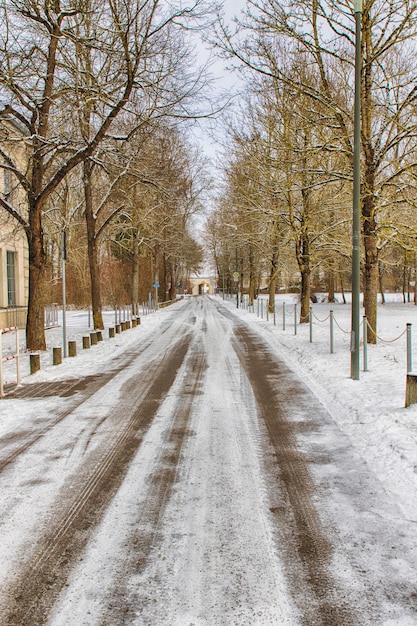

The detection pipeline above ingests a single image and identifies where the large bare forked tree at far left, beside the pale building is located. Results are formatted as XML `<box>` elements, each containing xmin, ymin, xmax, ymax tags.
<box><xmin>0</xmin><ymin>0</ymin><xmax>213</xmax><ymax>350</ymax></box>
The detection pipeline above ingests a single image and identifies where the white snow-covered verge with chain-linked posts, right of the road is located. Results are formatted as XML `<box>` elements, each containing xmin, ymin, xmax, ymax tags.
<box><xmin>231</xmin><ymin>294</ymin><xmax>417</xmax><ymax>521</ymax></box>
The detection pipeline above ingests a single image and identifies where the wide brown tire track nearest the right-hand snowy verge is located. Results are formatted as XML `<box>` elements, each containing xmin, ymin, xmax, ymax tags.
<box><xmin>226</xmin><ymin>309</ymin><xmax>357</xmax><ymax>626</ymax></box>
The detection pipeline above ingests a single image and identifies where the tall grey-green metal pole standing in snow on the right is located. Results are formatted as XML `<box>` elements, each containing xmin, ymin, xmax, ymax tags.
<box><xmin>350</xmin><ymin>0</ymin><xmax>362</xmax><ymax>380</ymax></box>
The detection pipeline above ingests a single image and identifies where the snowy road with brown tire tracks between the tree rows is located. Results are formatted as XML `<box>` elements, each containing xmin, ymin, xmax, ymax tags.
<box><xmin>0</xmin><ymin>298</ymin><xmax>417</xmax><ymax>626</ymax></box>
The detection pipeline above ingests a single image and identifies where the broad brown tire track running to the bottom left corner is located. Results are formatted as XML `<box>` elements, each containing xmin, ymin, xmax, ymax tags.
<box><xmin>0</xmin><ymin>335</ymin><xmax>191</xmax><ymax>626</ymax></box>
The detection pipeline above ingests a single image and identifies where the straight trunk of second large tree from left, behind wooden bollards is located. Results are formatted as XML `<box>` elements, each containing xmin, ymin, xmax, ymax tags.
<box><xmin>83</xmin><ymin>160</ymin><xmax>104</xmax><ymax>330</ymax></box>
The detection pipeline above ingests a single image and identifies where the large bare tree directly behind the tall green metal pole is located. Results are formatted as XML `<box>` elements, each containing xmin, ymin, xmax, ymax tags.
<box><xmin>217</xmin><ymin>0</ymin><xmax>417</xmax><ymax>342</ymax></box>
